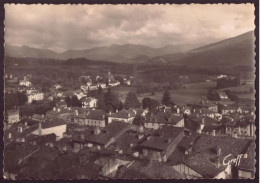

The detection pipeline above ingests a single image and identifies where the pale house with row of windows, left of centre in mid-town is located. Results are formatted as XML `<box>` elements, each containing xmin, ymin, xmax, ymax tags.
<box><xmin>74</xmin><ymin>110</ymin><xmax>106</xmax><ymax>127</ymax></box>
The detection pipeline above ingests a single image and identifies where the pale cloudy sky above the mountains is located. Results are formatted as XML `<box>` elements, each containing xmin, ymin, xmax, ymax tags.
<box><xmin>5</xmin><ymin>4</ymin><xmax>255</xmax><ymax>52</ymax></box>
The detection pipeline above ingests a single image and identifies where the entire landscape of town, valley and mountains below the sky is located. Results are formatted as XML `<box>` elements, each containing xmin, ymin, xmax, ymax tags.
<box><xmin>3</xmin><ymin>3</ymin><xmax>256</xmax><ymax>180</ymax></box>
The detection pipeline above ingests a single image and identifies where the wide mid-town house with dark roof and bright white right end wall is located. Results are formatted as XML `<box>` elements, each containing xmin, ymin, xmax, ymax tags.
<box><xmin>144</xmin><ymin>112</ymin><xmax>184</xmax><ymax>130</ymax></box>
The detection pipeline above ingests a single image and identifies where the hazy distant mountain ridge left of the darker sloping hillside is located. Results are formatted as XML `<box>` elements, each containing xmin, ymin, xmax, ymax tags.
<box><xmin>5</xmin><ymin>44</ymin><xmax>201</xmax><ymax>62</ymax></box>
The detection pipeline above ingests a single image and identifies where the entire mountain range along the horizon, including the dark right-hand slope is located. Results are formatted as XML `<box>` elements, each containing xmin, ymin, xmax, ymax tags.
<box><xmin>5</xmin><ymin>31</ymin><xmax>255</xmax><ymax>67</ymax></box>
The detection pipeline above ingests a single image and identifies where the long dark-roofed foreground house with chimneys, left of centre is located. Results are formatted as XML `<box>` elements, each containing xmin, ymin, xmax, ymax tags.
<box><xmin>72</xmin><ymin>121</ymin><xmax>130</xmax><ymax>152</ymax></box>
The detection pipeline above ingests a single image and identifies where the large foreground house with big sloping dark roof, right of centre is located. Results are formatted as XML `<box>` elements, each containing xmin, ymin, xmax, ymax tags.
<box><xmin>140</xmin><ymin>126</ymin><xmax>184</xmax><ymax>162</ymax></box>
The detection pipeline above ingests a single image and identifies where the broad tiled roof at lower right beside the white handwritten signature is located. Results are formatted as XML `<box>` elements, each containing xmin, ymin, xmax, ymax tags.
<box><xmin>184</xmin><ymin>134</ymin><xmax>250</xmax><ymax>178</ymax></box>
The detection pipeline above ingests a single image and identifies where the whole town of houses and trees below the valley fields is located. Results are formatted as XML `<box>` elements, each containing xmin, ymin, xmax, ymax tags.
<box><xmin>4</xmin><ymin>69</ymin><xmax>256</xmax><ymax>179</ymax></box>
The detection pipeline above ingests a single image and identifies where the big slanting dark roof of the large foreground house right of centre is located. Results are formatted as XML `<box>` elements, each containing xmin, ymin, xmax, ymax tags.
<box><xmin>141</xmin><ymin>126</ymin><xmax>184</xmax><ymax>151</ymax></box>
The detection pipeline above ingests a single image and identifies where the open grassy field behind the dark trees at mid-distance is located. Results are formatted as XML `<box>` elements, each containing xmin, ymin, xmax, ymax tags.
<box><xmin>113</xmin><ymin>82</ymin><xmax>216</xmax><ymax>105</ymax></box>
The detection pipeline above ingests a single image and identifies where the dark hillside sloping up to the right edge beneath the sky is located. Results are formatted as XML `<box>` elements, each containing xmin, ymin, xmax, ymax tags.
<box><xmin>153</xmin><ymin>31</ymin><xmax>255</xmax><ymax>67</ymax></box>
